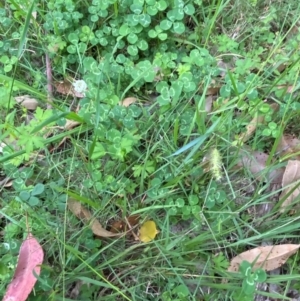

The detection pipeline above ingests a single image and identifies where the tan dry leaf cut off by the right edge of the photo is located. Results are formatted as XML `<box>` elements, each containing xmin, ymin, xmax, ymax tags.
<box><xmin>279</xmin><ymin>160</ymin><xmax>300</xmax><ymax>212</ymax></box>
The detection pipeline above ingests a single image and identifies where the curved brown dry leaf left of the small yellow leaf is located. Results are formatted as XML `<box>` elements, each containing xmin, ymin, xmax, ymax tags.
<box><xmin>68</xmin><ymin>199</ymin><xmax>120</xmax><ymax>237</ymax></box>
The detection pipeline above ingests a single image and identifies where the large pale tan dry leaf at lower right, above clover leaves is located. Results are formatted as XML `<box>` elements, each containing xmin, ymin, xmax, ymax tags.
<box><xmin>228</xmin><ymin>244</ymin><xmax>300</xmax><ymax>272</ymax></box>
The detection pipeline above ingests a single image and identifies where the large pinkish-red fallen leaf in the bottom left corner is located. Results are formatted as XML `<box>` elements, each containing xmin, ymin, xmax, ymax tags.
<box><xmin>3</xmin><ymin>233</ymin><xmax>44</xmax><ymax>301</ymax></box>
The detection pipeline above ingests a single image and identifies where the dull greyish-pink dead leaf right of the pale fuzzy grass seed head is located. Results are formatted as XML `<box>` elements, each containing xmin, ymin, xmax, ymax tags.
<box><xmin>237</xmin><ymin>149</ymin><xmax>284</xmax><ymax>184</ymax></box>
